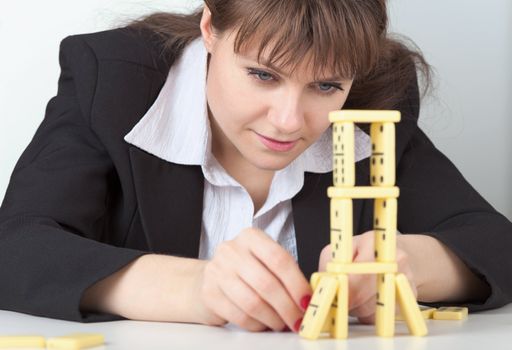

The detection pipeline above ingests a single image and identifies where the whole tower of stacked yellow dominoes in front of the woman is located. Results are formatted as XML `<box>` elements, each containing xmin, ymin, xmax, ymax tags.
<box><xmin>299</xmin><ymin>110</ymin><xmax>427</xmax><ymax>339</ymax></box>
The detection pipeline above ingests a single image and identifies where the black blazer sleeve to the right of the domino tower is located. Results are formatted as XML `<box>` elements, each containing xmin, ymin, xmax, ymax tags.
<box><xmin>397</xmin><ymin>78</ymin><xmax>512</xmax><ymax>311</ymax></box>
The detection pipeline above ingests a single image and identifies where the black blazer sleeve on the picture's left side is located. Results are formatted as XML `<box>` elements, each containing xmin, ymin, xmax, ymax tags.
<box><xmin>0</xmin><ymin>37</ymin><xmax>145</xmax><ymax>322</ymax></box>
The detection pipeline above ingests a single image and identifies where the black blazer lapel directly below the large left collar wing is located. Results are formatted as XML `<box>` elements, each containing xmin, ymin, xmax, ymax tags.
<box><xmin>129</xmin><ymin>146</ymin><xmax>204</xmax><ymax>258</ymax></box>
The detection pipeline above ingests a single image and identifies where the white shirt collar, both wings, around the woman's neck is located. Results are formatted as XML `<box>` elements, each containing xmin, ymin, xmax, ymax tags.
<box><xmin>124</xmin><ymin>38</ymin><xmax>371</xmax><ymax>175</ymax></box>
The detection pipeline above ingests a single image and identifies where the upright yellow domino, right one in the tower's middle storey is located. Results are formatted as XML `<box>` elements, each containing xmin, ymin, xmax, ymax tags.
<box><xmin>373</xmin><ymin>198</ymin><xmax>397</xmax><ymax>262</ymax></box>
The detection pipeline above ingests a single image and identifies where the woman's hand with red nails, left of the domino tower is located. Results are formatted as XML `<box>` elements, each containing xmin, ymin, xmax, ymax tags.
<box><xmin>194</xmin><ymin>228</ymin><xmax>312</xmax><ymax>331</ymax></box>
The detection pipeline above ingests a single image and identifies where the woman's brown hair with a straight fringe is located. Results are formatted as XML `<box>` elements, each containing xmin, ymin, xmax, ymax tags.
<box><xmin>129</xmin><ymin>0</ymin><xmax>430</xmax><ymax>109</ymax></box>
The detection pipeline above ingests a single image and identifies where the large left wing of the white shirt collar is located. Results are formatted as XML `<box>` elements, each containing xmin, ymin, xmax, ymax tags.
<box><xmin>124</xmin><ymin>39</ymin><xmax>211</xmax><ymax>165</ymax></box>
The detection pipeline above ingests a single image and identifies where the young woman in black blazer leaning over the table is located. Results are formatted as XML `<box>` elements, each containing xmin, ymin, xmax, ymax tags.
<box><xmin>0</xmin><ymin>0</ymin><xmax>512</xmax><ymax>331</ymax></box>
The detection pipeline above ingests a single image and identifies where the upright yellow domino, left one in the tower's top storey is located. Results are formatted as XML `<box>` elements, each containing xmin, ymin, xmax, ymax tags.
<box><xmin>332</xmin><ymin>122</ymin><xmax>356</xmax><ymax>187</ymax></box>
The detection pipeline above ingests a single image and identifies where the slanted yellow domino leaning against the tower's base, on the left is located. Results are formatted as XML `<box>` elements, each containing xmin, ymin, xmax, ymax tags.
<box><xmin>299</xmin><ymin>276</ymin><xmax>338</xmax><ymax>339</ymax></box>
